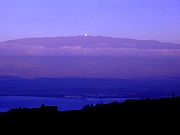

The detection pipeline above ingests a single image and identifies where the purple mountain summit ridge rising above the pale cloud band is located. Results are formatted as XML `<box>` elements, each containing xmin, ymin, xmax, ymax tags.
<box><xmin>0</xmin><ymin>36</ymin><xmax>180</xmax><ymax>49</ymax></box>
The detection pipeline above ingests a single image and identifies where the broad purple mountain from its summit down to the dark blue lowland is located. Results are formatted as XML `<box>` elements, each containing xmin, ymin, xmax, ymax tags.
<box><xmin>0</xmin><ymin>36</ymin><xmax>180</xmax><ymax>79</ymax></box>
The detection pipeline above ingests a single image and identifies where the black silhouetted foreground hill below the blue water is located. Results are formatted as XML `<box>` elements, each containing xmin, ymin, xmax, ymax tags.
<box><xmin>0</xmin><ymin>97</ymin><xmax>180</xmax><ymax>134</ymax></box>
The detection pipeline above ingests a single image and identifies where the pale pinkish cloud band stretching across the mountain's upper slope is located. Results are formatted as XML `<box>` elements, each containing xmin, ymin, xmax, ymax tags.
<box><xmin>0</xmin><ymin>46</ymin><xmax>180</xmax><ymax>57</ymax></box>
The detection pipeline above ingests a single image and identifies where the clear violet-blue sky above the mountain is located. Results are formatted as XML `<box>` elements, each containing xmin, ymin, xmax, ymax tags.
<box><xmin>0</xmin><ymin>0</ymin><xmax>180</xmax><ymax>43</ymax></box>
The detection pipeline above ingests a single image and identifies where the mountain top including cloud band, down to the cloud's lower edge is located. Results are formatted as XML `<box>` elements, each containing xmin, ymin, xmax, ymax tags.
<box><xmin>0</xmin><ymin>36</ymin><xmax>180</xmax><ymax>56</ymax></box>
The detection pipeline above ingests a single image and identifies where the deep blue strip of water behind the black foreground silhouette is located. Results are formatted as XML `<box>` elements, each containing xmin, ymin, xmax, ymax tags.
<box><xmin>0</xmin><ymin>96</ymin><xmax>127</xmax><ymax>112</ymax></box>
